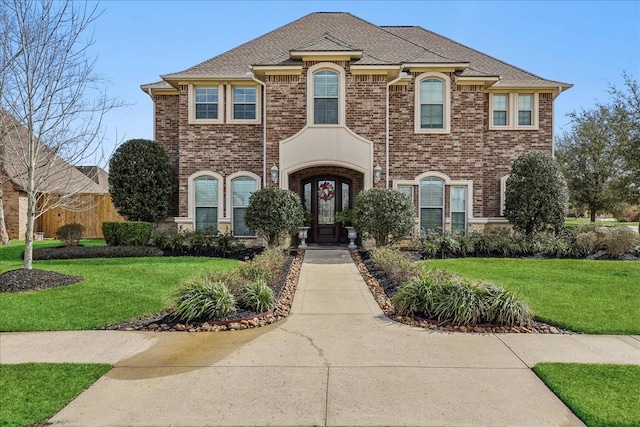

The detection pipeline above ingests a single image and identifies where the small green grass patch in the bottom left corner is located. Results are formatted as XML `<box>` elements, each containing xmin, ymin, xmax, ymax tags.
<box><xmin>0</xmin><ymin>363</ymin><xmax>111</xmax><ymax>427</ymax></box>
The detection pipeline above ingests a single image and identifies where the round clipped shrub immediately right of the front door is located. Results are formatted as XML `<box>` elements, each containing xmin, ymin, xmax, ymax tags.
<box><xmin>353</xmin><ymin>188</ymin><xmax>413</xmax><ymax>247</ymax></box>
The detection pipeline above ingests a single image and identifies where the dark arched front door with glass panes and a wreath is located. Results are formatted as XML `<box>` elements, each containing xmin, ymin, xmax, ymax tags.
<box><xmin>302</xmin><ymin>177</ymin><xmax>351</xmax><ymax>243</ymax></box>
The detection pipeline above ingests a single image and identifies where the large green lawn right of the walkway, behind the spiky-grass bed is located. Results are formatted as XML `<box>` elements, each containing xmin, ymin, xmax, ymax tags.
<box><xmin>428</xmin><ymin>258</ymin><xmax>640</xmax><ymax>334</ymax></box>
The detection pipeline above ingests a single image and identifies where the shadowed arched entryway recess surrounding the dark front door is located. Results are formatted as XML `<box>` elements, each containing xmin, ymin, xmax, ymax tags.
<box><xmin>289</xmin><ymin>167</ymin><xmax>364</xmax><ymax>244</ymax></box>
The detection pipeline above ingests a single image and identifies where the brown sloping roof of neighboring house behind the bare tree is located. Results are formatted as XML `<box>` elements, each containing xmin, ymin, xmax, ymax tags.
<box><xmin>0</xmin><ymin>109</ymin><xmax>108</xmax><ymax>195</ymax></box>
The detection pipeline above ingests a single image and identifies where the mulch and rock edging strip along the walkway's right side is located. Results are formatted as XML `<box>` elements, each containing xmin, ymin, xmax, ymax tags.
<box><xmin>350</xmin><ymin>251</ymin><xmax>574</xmax><ymax>334</ymax></box>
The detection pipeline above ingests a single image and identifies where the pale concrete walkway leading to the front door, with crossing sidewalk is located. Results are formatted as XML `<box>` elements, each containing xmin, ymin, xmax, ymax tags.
<box><xmin>0</xmin><ymin>250</ymin><xmax>640</xmax><ymax>427</ymax></box>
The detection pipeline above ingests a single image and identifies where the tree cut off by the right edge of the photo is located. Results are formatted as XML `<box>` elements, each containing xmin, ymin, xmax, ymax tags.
<box><xmin>609</xmin><ymin>73</ymin><xmax>640</xmax><ymax>232</ymax></box>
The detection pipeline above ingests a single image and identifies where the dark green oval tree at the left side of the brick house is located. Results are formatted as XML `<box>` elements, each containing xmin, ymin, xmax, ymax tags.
<box><xmin>109</xmin><ymin>139</ymin><xmax>171</xmax><ymax>222</ymax></box>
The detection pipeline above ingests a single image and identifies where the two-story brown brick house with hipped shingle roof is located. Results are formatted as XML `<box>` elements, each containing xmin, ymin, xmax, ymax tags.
<box><xmin>142</xmin><ymin>13</ymin><xmax>571</xmax><ymax>246</ymax></box>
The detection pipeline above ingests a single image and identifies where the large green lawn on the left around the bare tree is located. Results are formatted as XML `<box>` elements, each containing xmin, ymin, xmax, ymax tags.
<box><xmin>0</xmin><ymin>241</ymin><xmax>238</xmax><ymax>331</ymax></box>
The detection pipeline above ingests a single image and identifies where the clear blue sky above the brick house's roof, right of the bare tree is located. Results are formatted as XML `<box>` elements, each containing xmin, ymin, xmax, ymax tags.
<box><xmin>91</xmin><ymin>1</ymin><xmax>640</xmax><ymax>164</ymax></box>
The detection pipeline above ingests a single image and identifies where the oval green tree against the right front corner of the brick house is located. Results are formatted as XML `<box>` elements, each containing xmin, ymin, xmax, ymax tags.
<box><xmin>504</xmin><ymin>151</ymin><xmax>569</xmax><ymax>238</ymax></box>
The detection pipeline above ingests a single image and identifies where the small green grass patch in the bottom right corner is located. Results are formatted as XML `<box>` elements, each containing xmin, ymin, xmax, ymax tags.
<box><xmin>533</xmin><ymin>363</ymin><xmax>640</xmax><ymax>427</ymax></box>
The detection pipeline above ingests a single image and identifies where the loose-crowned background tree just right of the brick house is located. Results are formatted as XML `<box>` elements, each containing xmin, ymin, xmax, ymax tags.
<box><xmin>555</xmin><ymin>105</ymin><xmax>621</xmax><ymax>222</ymax></box>
